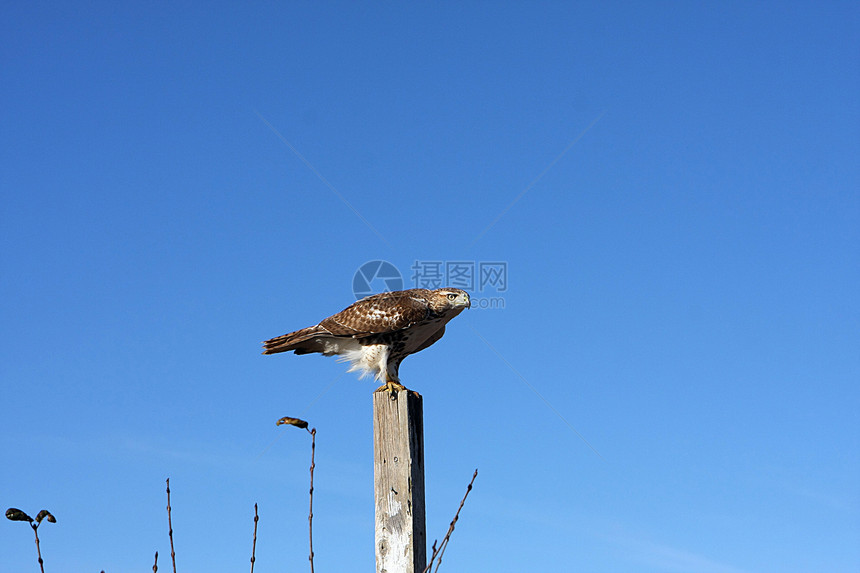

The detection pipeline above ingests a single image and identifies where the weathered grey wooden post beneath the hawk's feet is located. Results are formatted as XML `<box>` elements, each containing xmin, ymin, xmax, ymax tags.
<box><xmin>373</xmin><ymin>390</ymin><xmax>427</xmax><ymax>573</ymax></box>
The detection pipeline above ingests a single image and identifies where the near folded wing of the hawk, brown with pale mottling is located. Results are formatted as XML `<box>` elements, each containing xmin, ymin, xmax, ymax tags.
<box><xmin>319</xmin><ymin>289</ymin><xmax>430</xmax><ymax>338</ymax></box>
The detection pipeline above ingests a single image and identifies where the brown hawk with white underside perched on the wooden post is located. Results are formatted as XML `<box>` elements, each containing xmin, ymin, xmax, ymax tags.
<box><xmin>263</xmin><ymin>288</ymin><xmax>472</xmax><ymax>392</ymax></box>
